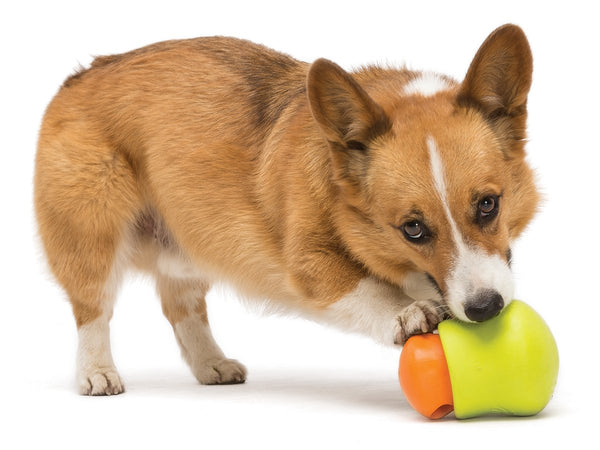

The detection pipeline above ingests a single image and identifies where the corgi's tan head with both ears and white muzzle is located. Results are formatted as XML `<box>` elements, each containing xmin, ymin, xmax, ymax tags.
<box><xmin>308</xmin><ymin>25</ymin><xmax>538</xmax><ymax>321</ymax></box>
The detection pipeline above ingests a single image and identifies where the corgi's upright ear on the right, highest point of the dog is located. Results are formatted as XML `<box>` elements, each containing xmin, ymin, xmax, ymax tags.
<box><xmin>458</xmin><ymin>24</ymin><xmax>533</xmax><ymax>147</ymax></box>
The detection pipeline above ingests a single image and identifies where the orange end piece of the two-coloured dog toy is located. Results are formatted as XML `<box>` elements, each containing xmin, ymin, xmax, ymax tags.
<box><xmin>398</xmin><ymin>333</ymin><xmax>454</xmax><ymax>419</ymax></box>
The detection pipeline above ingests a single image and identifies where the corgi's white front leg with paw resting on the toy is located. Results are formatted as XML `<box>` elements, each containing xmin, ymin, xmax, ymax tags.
<box><xmin>319</xmin><ymin>277</ymin><xmax>445</xmax><ymax>345</ymax></box>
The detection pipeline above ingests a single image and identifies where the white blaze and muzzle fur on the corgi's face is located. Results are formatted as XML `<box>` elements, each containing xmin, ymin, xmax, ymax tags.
<box><xmin>427</xmin><ymin>136</ymin><xmax>514</xmax><ymax>321</ymax></box>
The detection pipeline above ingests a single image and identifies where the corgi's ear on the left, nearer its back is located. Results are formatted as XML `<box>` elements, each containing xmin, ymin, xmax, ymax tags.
<box><xmin>307</xmin><ymin>59</ymin><xmax>389</xmax><ymax>150</ymax></box>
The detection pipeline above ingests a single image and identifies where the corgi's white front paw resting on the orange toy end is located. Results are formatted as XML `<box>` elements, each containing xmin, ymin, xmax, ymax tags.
<box><xmin>394</xmin><ymin>300</ymin><xmax>446</xmax><ymax>345</ymax></box>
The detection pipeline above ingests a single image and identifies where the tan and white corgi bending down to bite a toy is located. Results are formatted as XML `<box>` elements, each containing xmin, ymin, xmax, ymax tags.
<box><xmin>34</xmin><ymin>25</ymin><xmax>538</xmax><ymax>395</ymax></box>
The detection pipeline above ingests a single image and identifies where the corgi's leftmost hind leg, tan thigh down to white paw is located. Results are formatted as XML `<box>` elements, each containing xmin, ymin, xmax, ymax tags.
<box><xmin>35</xmin><ymin>126</ymin><xmax>140</xmax><ymax>395</ymax></box>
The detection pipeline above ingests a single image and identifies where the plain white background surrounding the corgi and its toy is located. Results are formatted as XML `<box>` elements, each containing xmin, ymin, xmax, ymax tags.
<box><xmin>0</xmin><ymin>0</ymin><xmax>600</xmax><ymax>449</ymax></box>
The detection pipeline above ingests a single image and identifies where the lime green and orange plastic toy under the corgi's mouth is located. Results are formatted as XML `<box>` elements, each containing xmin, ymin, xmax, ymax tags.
<box><xmin>398</xmin><ymin>300</ymin><xmax>558</xmax><ymax>419</ymax></box>
